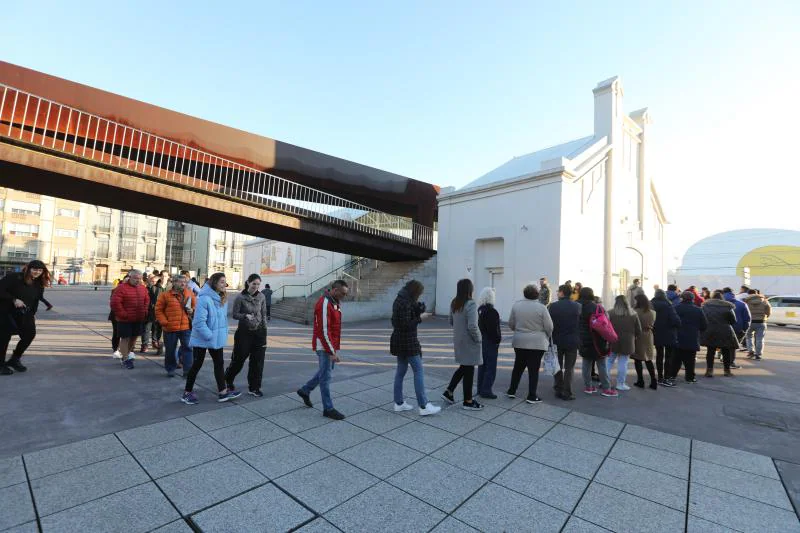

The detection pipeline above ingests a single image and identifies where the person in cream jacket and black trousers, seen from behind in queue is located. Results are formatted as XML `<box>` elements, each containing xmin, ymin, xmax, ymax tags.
<box><xmin>506</xmin><ymin>284</ymin><xmax>553</xmax><ymax>403</ymax></box>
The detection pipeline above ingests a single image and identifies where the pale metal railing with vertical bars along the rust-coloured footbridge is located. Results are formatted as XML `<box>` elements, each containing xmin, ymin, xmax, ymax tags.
<box><xmin>0</xmin><ymin>83</ymin><xmax>434</xmax><ymax>250</ymax></box>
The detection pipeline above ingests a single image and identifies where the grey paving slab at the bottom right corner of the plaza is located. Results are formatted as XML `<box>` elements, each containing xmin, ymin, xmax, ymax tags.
<box><xmin>689</xmin><ymin>483</ymin><xmax>800</xmax><ymax>533</ymax></box>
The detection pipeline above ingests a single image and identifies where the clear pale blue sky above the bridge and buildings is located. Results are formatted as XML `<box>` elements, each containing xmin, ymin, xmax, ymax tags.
<box><xmin>0</xmin><ymin>0</ymin><xmax>800</xmax><ymax>254</ymax></box>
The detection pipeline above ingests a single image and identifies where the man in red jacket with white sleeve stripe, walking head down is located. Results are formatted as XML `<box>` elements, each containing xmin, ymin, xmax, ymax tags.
<box><xmin>297</xmin><ymin>280</ymin><xmax>350</xmax><ymax>420</ymax></box>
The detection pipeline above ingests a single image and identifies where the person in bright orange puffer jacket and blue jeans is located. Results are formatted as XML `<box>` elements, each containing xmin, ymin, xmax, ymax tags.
<box><xmin>155</xmin><ymin>275</ymin><xmax>197</xmax><ymax>378</ymax></box>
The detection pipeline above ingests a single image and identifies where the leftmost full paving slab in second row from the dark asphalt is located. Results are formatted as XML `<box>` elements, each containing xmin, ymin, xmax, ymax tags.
<box><xmin>31</xmin><ymin>455</ymin><xmax>150</xmax><ymax>516</ymax></box>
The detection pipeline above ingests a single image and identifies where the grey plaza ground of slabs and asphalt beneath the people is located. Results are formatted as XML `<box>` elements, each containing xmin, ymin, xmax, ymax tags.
<box><xmin>0</xmin><ymin>291</ymin><xmax>800</xmax><ymax>533</ymax></box>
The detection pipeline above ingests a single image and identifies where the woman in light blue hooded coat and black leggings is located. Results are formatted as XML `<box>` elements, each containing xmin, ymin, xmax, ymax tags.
<box><xmin>181</xmin><ymin>272</ymin><xmax>242</xmax><ymax>405</ymax></box>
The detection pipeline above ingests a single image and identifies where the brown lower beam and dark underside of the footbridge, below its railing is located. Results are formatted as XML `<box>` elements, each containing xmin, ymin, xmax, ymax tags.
<box><xmin>0</xmin><ymin>142</ymin><xmax>435</xmax><ymax>261</ymax></box>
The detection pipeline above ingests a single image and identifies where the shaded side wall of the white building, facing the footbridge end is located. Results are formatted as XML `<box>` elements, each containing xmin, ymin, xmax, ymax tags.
<box><xmin>436</xmin><ymin>174</ymin><xmax>561</xmax><ymax>320</ymax></box>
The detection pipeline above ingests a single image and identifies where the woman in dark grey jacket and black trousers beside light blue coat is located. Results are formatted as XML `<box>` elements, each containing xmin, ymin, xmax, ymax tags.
<box><xmin>225</xmin><ymin>274</ymin><xmax>267</xmax><ymax>398</ymax></box>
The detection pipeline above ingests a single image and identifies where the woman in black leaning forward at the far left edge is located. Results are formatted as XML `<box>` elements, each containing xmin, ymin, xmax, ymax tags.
<box><xmin>0</xmin><ymin>259</ymin><xmax>50</xmax><ymax>376</ymax></box>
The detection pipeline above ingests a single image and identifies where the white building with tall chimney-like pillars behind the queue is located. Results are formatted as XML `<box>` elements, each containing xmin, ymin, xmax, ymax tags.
<box><xmin>436</xmin><ymin>77</ymin><xmax>667</xmax><ymax>317</ymax></box>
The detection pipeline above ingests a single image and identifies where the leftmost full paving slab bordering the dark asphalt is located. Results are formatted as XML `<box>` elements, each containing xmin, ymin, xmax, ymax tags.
<box><xmin>25</xmin><ymin>435</ymin><xmax>128</xmax><ymax>479</ymax></box>
